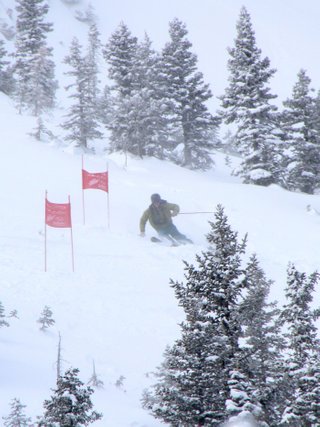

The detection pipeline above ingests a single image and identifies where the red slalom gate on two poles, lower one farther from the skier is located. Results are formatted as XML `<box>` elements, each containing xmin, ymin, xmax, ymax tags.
<box><xmin>44</xmin><ymin>191</ymin><xmax>74</xmax><ymax>271</ymax></box>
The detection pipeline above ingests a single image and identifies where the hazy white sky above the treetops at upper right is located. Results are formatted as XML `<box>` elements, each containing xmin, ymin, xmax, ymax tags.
<box><xmin>70</xmin><ymin>0</ymin><xmax>320</xmax><ymax>110</ymax></box>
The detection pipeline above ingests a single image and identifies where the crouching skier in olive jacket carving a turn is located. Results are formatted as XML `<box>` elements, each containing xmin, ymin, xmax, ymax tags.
<box><xmin>140</xmin><ymin>194</ymin><xmax>192</xmax><ymax>243</ymax></box>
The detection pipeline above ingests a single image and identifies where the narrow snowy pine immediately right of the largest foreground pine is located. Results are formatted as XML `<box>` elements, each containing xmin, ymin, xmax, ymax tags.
<box><xmin>241</xmin><ymin>255</ymin><xmax>285</xmax><ymax>427</ymax></box>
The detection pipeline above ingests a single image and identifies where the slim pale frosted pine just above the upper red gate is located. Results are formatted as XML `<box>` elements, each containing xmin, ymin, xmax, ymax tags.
<box><xmin>61</xmin><ymin>37</ymin><xmax>102</xmax><ymax>149</ymax></box>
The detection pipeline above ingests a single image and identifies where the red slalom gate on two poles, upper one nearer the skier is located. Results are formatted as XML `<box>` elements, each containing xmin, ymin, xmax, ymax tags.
<box><xmin>82</xmin><ymin>156</ymin><xmax>110</xmax><ymax>228</ymax></box>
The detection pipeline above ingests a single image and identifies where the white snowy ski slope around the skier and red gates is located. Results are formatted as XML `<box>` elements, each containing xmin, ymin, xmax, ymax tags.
<box><xmin>0</xmin><ymin>0</ymin><xmax>320</xmax><ymax>427</ymax></box>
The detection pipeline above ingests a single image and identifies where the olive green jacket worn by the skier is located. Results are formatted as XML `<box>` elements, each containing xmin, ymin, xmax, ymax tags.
<box><xmin>140</xmin><ymin>200</ymin><xmax>180</xmax><ymax>233</ymax></box>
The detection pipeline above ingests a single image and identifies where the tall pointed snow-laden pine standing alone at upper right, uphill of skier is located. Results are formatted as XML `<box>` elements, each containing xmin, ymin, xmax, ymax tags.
<box><xmin>221</xmin><ymin>7</ymin><xmax>280</xmax><ymax>185</ymax></box>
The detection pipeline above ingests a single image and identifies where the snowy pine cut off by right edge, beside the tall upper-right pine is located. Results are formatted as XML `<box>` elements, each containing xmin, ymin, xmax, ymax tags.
<box><xmin>280</xmin><ymin>70</ymin><xmax>320</xmax><ymax>194</ymax></box>
